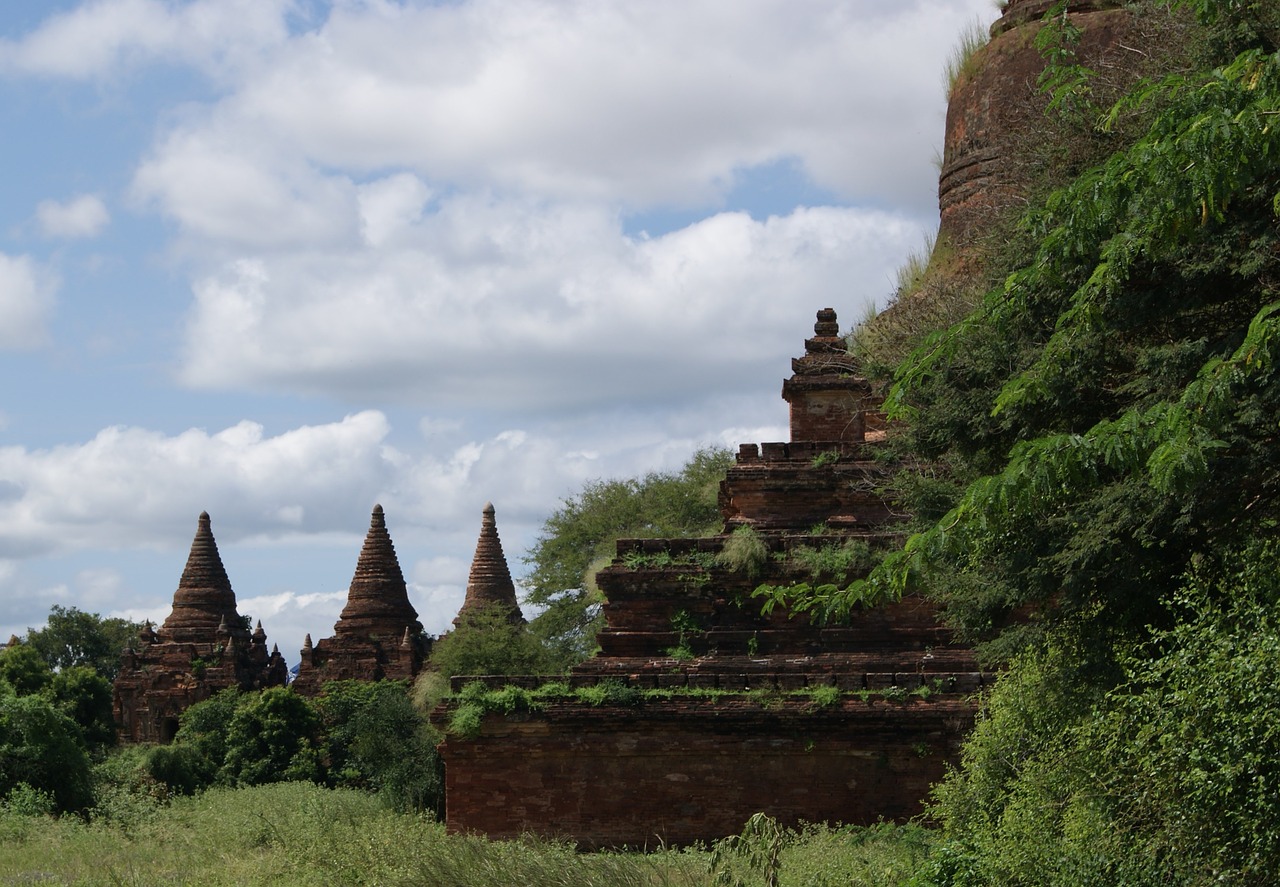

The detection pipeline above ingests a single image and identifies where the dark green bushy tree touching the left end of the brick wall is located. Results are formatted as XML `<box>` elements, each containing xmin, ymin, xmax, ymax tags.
<box><xmin>316</xmin><ymin>681</ymin><xmax>444</xmax><ymax>813</ymax></box>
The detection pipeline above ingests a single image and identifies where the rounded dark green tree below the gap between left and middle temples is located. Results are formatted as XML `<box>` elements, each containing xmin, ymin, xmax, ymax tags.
<box><xmin>220</xmin><ymin>687</ymin><xmax>324</xmax><ymax>786</ymax></box>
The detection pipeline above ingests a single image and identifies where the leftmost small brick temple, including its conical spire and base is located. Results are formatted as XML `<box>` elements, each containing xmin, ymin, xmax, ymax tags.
<box><xmin>114</xmin><ymin>512</ymin><xmax>288</xmax><ymax>742</ymax></box>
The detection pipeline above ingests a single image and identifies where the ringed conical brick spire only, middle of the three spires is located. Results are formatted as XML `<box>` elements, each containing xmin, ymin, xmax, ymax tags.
<box><xmin>333</xmin><ymin>506</ymin><xmax>422</xmax><ymax>643</ymax></box>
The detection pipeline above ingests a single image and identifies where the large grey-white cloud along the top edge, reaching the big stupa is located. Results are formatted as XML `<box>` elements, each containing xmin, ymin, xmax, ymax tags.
<box><xmin>127</xmin><ymin>0</ymin><xmax>989</xmax><ymax>217</ymax></box>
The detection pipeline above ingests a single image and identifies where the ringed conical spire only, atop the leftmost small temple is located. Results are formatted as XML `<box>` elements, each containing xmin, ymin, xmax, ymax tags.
<box><xmin>157</xmin><ymin>512</ymin><xmax>244</xmax><ymax>641</ymax></box>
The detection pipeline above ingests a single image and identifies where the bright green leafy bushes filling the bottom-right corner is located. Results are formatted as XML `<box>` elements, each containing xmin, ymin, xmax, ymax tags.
<box><xmin>928</xmin><ymin>541</ymin><xmax>1280</xmax><ymax>887</ymax></box>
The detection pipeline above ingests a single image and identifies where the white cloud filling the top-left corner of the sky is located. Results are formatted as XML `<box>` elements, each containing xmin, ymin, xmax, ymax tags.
<box><xmin>0</xmin><ymin>0</ymin><xmax>293</xmax><ymax>79</ymax></box>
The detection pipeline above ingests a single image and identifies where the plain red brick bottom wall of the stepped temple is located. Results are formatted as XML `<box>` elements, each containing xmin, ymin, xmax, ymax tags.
<box><xmin>442</xmin><ymin>696</ymin><xmax>973</xmax><ymax>847</ymax></box>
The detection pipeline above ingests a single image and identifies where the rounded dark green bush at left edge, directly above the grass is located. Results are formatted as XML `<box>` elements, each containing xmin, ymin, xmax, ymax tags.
<box><xmin>0</xmin><ymin>695</ymin><xmax>93</xmax><ymax>811</ymax></box>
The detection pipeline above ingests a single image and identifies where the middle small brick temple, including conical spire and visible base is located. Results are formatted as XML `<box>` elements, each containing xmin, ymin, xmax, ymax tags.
<box><xmin>292</xmin><ymin>506</ymin><xmax>431</xmax><ymax>696</ymax></box>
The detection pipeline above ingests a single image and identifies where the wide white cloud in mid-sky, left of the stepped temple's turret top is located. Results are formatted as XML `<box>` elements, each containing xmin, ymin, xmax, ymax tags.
<box><xmin>175</xmin><ymin>197</ymin><xmax>920</xmax><ymax>411</ymax></box>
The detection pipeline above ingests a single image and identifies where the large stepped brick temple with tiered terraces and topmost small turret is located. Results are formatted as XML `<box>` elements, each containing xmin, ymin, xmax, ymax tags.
<box><xmin>434</xmin><ymin>308</ymin><xmax>989</xmax><ymax>847</ymax></box>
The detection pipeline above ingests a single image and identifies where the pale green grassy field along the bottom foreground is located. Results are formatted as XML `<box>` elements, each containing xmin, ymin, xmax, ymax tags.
<box><xmin>0</xmin><ymin>783</ymin><xmax>928</xmax><ymax>887</ymax></box>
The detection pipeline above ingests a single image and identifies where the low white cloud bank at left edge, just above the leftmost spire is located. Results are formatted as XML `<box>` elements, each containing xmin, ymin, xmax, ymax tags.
<box><xmin>0</xmin><ymin>411</ymin><xmax>389</xmax><ymax>555</ymax></box>
